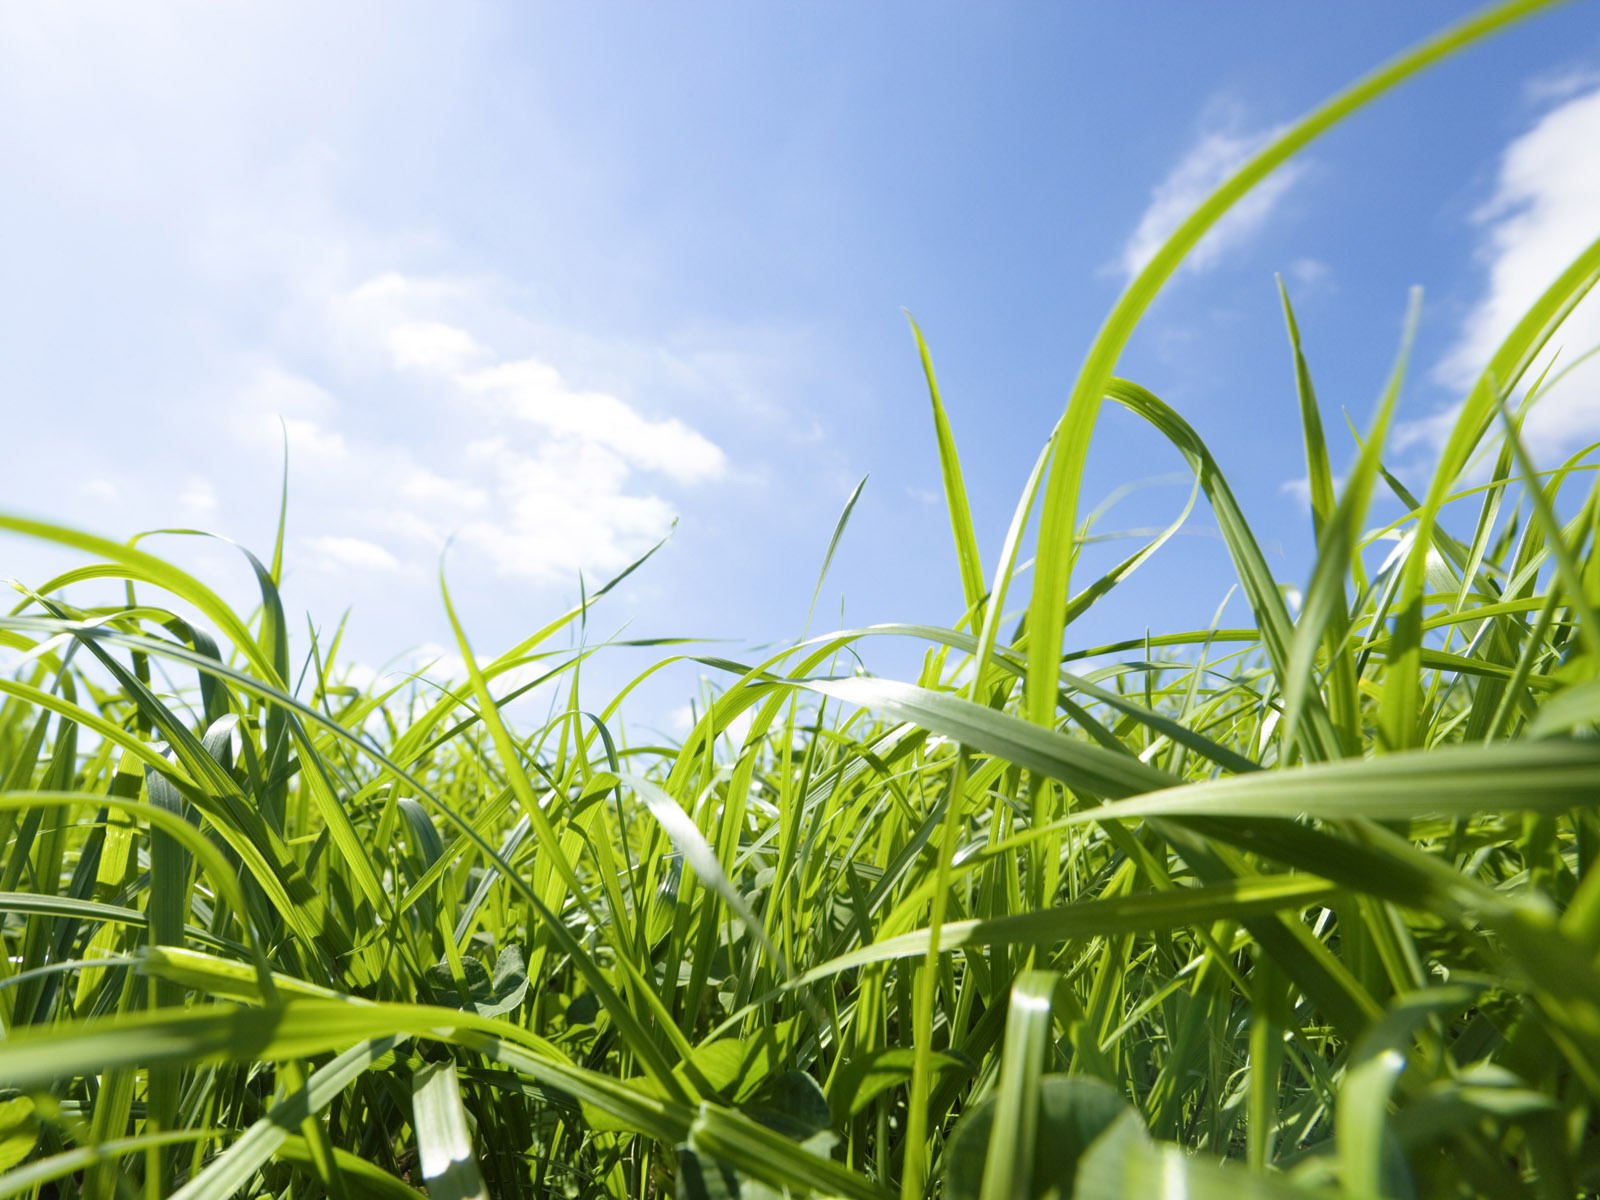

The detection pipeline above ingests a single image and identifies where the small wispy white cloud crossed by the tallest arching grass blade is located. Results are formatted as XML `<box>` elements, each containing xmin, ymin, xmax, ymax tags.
<box><xmin>1117</xmin><ymin>128</ymin><xmax>1306</xmax><ymax>278</ymax></box>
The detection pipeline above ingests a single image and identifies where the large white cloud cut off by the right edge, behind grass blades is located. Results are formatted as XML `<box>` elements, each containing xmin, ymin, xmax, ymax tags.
<box><xmin>1395</xmin><ymin>88</ymin><xmax>1600</xmax><ymax>461</ymax></box>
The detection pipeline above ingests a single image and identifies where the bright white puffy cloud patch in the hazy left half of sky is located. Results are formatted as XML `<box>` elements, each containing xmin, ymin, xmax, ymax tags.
<box><xmin>262</xmin><ymin>270</ymin><xmax>726</xmax><ymax>592</ymax></box>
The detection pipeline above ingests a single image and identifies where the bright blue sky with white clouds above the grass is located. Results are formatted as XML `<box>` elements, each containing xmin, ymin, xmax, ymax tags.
<box><xmin>0</xmin><ymin>0</ymin><xmax>1600</xmax><ymax>722</ymax></box>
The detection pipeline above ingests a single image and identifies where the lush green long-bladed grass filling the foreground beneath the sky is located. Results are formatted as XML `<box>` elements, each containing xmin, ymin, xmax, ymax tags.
<box><xmin>0</xmin><ymin>2</ymin><xmax>1600</xmax><ymax>1200</ymax></box>
